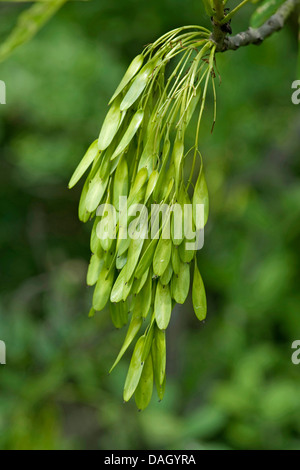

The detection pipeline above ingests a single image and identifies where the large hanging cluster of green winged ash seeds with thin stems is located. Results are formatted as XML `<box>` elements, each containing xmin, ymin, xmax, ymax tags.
<box><xmin>69</xmin><ymin>0</ymin><xmax>298</xmax><ymax>410</ymax></box>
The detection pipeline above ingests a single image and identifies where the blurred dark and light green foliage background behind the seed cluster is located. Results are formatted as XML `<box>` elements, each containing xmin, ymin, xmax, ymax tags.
<box><xmin>0</xmin><ymin>0</ymin><xmax>300</xmax><ymax>450</ymax></box>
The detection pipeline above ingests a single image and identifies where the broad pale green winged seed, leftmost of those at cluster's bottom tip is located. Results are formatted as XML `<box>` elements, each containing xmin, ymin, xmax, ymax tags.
<box><xmin>123</xmin><ymin>336</ymin><xmax>145</xmax><ymax>401</ymax></box>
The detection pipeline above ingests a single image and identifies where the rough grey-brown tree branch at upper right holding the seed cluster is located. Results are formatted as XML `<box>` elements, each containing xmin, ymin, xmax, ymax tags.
<box><xmin>211</xmin><ymin>0</ymin><xmax>299</xmax><ymax>52</ymax></box>
